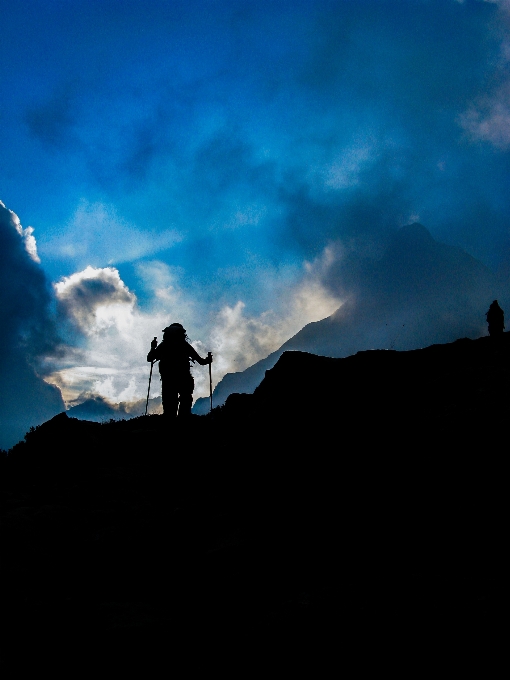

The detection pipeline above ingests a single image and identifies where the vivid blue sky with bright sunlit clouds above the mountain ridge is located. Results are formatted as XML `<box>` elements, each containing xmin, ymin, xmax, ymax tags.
<box><xmin>0</xmin><ymin>0</ymin><xmax>510</xmax><ymax>444</ymax></box>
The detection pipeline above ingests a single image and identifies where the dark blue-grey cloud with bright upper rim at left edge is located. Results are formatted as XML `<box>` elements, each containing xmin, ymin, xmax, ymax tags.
<box><xmin>0</xmin><ymin>201</ymin><xmax>64</xmax><ymax>448</ymax></box>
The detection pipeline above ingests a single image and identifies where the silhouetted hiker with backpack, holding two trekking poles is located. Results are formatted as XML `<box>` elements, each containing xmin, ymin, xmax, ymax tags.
<box><xmin>147</xmin><ymin>323</ymin><xmax>212</xmax><ymax>418</ymax></box>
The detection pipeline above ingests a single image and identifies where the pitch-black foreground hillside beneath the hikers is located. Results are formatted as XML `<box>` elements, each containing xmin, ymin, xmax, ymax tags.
<box><xmin>1</xmin><ymin>333</ymin><xmax>510</xmax><ymax>677</ymax></box>
